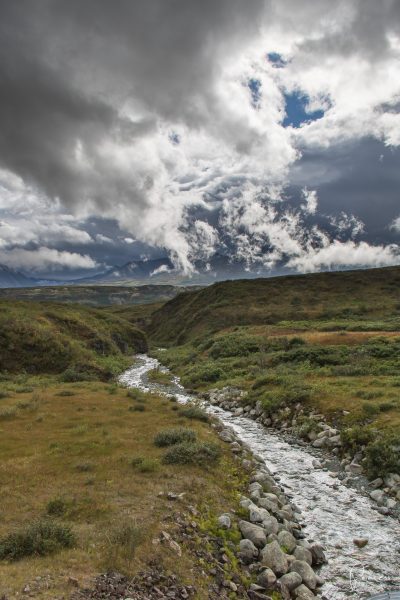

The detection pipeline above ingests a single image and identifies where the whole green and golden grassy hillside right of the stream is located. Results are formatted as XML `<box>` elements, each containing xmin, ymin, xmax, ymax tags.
<box><xmin>149</xmin><ymin>268</ymin><xmax>400</xmax><ymax>475</ymax></box>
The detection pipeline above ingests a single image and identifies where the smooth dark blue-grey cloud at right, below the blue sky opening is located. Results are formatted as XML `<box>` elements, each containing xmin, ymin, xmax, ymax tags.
<box><xmin>288</xmin><ymin>138</ymin><xmax>400</xmax><ymax>243</ymax></box>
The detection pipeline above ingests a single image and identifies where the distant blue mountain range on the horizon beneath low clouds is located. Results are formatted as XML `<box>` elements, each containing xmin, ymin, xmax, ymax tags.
<box><xmin>0</xmin><ymin>254</ymin><xmax>271</xmax><ymax>288</ymax></box>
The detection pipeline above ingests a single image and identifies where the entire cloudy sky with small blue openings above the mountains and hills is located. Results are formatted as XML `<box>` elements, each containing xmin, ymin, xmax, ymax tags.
<box><xmin>0</xmin><ymin>0</ymin><xmax>400</xmax><ymax>279</ymax></box>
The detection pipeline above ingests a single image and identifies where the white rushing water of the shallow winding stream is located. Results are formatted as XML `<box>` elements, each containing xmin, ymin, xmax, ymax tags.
<box><xmin>120</xmin><ymin>355</ymin><xmax>400</xmax><ymax>600</ymax></box>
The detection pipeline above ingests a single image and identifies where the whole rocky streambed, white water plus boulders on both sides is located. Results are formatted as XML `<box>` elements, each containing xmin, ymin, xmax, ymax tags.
<box><xmin>121</xmin><ymin>355</ymin><xmax>400</xmax><ymax>600</ymax></box>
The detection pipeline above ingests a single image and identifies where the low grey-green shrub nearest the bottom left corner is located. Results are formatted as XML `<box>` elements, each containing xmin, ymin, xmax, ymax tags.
<box><xmin>0</xmin><ymin>519</ymin><xmax>76</xmax><ymax>561</ymax></box>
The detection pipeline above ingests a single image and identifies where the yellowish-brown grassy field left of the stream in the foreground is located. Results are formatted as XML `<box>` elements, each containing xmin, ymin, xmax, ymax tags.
<box><xmin>0</xmin><ymin>376</ymin><xmax>248</xmax><ymax>600</ymax></box>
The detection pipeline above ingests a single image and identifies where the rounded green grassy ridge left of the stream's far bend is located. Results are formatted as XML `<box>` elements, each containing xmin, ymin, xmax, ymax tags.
<box><xmin>0</xmin><ymin>301</ymin><xmax>147</xmax><ymax>379</ymax></box>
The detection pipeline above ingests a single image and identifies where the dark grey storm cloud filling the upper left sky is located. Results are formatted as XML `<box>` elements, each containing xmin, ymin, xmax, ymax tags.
<box><xmin>0</xmin><ymin>0</ymin><xmax>264</xmax><ymax>205</ymax></box>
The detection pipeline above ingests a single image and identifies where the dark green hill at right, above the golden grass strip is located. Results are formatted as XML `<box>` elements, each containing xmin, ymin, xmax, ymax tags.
<box><xmin>149</xmin><ymin>267</ymin><xmax>400</xmax><ymax>344</ymax></box>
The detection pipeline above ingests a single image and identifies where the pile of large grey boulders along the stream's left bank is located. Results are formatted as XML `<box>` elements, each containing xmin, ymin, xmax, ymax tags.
<box><xmin>219</xmin><ymin>428</ymin><xmax>326</xmax><ymax>600</ymax></box>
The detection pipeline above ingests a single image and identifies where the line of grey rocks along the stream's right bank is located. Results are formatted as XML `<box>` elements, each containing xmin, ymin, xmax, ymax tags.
<box><xmin>202</xmin><ymin>387</ymin><xmax>400</xmax><ymax>515</ymax></box>
